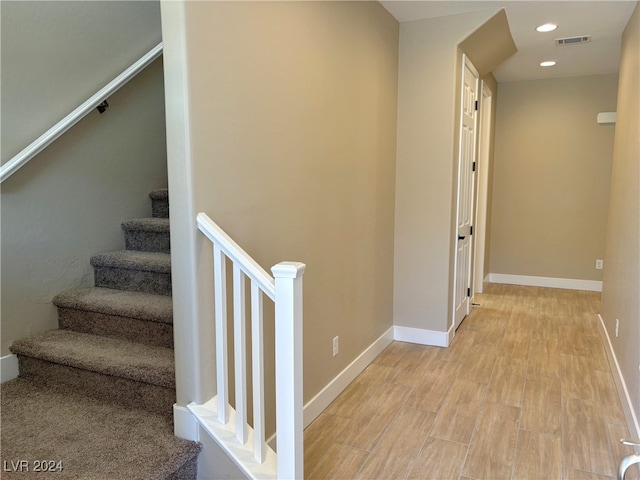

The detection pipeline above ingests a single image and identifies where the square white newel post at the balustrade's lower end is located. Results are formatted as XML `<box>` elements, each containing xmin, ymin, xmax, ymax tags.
<box><xmin>271</xmin><ymin>262</ymin><xmax>306</xmax><ymax>479</ymax></box>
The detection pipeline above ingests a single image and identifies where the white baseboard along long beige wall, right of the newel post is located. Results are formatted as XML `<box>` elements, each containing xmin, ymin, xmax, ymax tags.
<box><xmin>304</xmin><ymin>327</ymin><xmax>397</xmax><ymax>427</ymax></box>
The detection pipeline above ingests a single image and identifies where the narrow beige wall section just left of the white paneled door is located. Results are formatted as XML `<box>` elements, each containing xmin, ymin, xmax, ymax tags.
<box><xmin>393</xmin><ymin>12</ymin><xmax>502</xmax><ymax>332</ymax></box>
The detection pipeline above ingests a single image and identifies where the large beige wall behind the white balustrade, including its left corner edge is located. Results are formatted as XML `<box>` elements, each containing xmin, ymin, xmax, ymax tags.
<box><xmin>162</xmin><ymin>2</ymin><xmax>399</xmax><ymax>403</ymax></box>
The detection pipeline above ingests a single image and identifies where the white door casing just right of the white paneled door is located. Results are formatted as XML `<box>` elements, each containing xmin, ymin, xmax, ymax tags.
<box><xmin>472</xmin><ymin>81</ymin><xmax>493</xmax><ymax>294</ymax></box>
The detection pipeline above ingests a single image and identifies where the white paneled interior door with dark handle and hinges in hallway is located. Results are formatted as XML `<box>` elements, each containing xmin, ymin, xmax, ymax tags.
<box><xmin>453</xmin><ymin>55</ymin><xmax>478</xmax><ymax>330</ymax></box>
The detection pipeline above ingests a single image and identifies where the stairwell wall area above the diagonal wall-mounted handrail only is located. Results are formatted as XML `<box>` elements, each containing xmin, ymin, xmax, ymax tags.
<box><xmin>0</xmin><ymin>0</ymin><xmax>162</xmax><ymax>163</ymax></box>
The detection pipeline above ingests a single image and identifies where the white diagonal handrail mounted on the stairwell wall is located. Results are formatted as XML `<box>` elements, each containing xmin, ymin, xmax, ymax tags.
<box><xmin>0</xmin><ymin>42</ymin><xmax>162</xmax><ymax>183</ymax></box>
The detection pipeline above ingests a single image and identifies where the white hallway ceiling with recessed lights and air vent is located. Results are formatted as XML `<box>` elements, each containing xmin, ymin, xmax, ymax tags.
<box><xmin>380</xmin><ymin>0</ymin><xmax>638</xmax><ymax>82</ymax></box>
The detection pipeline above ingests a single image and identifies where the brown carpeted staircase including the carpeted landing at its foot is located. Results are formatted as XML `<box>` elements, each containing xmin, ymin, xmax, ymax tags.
<box><xmin>0</xmin><ymin>189</ymin><xmax>201</xmax><ymax>480</ymax></box>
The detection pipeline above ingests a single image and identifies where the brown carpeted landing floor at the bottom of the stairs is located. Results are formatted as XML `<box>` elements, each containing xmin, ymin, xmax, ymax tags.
<box><xmin>0</xmin><ymin>378</ymin><xmax>201</xmax><ymax>480</ymax></box>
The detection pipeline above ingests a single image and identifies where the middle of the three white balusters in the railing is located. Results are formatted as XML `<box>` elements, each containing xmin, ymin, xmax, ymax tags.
<box><xmin>233</xmin><ymin>263</ymin><xmax>248</xmax><ymax>445</ymax></box>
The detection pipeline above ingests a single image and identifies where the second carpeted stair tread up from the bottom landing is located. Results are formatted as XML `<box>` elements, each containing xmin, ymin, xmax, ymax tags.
<box><xmin>53</xmin><ymin>287</ymin><xmax>173</xmax><ymax>323</ymax></box>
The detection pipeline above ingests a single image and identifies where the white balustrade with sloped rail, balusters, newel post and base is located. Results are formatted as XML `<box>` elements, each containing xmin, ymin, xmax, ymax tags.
<box><xmin>187</xmin><ymin>213</ymin><xmax>306</xmax><ymax>479</ymax></box>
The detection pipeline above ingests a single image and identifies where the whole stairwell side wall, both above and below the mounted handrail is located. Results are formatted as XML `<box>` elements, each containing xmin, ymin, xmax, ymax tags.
<box><xmin>0</xmin><ymin>1</ymin><xmax>167</xmax><ymax>356</ymax></box>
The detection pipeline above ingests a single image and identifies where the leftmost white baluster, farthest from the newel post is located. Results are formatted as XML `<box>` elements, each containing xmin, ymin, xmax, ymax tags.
<box><xmin>213</xmin><ymin>245</ymin><xmax>229</xmax><ymax>425</ymax></box>
